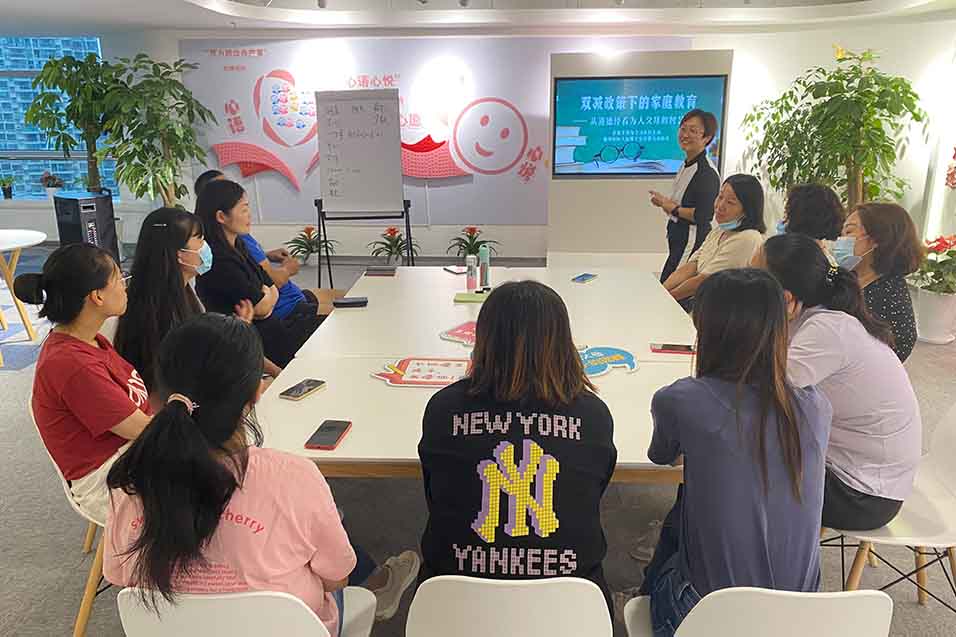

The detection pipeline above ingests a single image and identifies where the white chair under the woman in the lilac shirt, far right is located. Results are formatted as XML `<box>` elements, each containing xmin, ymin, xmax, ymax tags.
<box><xmin>834</xmin><ymin>407</ymin><xmax>956</xmax><ymax>612</ymax></box>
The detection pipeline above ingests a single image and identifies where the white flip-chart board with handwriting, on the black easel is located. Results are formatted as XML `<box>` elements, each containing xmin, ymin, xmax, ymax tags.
<box><xmin>315</xmin><ymin>89</ymin><xmax>405</xmax><ymax>215</ymax></box>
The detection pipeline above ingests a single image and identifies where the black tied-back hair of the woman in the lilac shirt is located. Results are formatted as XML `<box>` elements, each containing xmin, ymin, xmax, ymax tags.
<box><xmin>763</xmin><ymin>232</ymin><xmax>894</xmax><ymax>347</ymax></box>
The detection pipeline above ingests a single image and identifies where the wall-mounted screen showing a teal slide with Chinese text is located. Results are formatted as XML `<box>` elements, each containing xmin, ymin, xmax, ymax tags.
<box><xmin>552</xmin><ymin>75</ymin><xmax>727</xmax><ymax>176</ymax></box>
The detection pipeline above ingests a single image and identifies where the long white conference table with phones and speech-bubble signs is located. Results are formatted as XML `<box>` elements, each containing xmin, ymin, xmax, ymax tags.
<box><xmin>256</xmin><ymin>267</ymin><xmax>695</xmax><ymax>483</ymax></box>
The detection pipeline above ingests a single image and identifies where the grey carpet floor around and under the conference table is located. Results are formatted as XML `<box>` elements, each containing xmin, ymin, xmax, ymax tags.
<box><xmin>0</xmin><ymin>256</ymin><xmax>956</xmax><ymax>637</ymax></box>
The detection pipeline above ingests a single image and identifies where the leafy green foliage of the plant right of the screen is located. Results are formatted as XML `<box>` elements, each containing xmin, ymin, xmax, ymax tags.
<box><xmin>744</xmin><ymin>47</ymin><xmax>926</xmax><ymax>206</ymax></box>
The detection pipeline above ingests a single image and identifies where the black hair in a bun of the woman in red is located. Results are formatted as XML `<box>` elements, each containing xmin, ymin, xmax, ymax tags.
<box><xmin>13</xmin><ymin>243</ymin><xmax>119</xmax><ymax>325</ymax></box>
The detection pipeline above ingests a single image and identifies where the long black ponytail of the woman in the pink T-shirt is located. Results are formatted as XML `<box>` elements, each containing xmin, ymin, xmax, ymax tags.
<box><xmin>107</xmin><ymin>313</ymin><xmax>262</xmax><ymax>608</ymax></box>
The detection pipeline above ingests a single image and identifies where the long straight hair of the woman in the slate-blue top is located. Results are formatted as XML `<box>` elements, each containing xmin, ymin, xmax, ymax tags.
<box><xmin>694</xmin><ymin>268</ymin><xmax>803</xmax><ymax>501</ymax></box>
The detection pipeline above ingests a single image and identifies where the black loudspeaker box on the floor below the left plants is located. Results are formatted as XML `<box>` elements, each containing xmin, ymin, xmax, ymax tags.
<box><xmin>53</xmin><ymin>188</ymin><xmax>120</xmax><ymax>263</ymax></box>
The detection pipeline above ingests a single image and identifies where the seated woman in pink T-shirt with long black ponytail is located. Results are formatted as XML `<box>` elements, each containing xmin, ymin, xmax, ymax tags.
<box><xmin>103</xmin><ymin>313</ymin><xmax>418</xmax><ymax>635</ymax></box>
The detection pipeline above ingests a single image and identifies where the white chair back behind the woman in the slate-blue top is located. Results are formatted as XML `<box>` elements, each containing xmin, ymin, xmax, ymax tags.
<box><xmin>624</xmin><ymin>588</ymin><xmax>893</xmax><ymax>637</ymax></box>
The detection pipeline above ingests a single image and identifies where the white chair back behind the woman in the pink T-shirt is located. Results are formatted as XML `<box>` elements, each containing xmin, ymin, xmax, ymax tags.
<box><xmin>116</xmin><ymin>586</ymin><xmax>375</xmax><ymax>637</ymax></box>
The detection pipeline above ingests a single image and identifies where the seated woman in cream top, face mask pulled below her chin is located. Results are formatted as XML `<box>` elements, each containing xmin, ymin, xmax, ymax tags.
<box><xmin>664</xmin><ymin>175</ymin><xmax>767</xmax><ymax>312</ymax></box>
